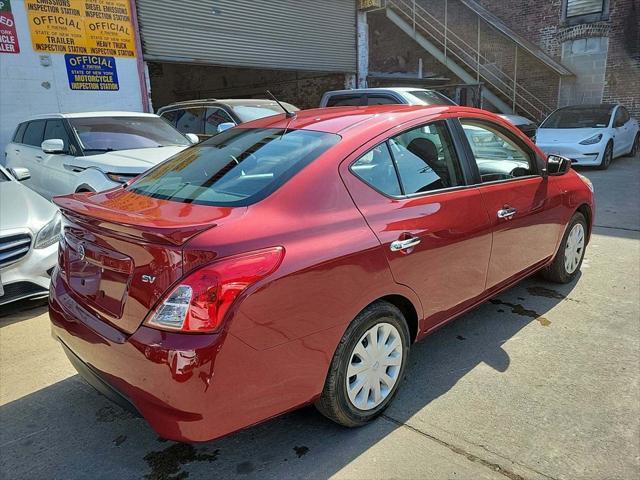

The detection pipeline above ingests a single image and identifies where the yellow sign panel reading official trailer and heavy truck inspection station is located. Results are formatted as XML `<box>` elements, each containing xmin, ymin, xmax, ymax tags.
<box><xmin>25</xmin><ymin>0</ymin><xmax>136</xmax><ymax>57</ymax></box>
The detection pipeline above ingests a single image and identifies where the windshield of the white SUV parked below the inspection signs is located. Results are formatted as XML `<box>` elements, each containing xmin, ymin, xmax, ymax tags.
<box><xmin>69</xmin><ymin>117</ymin><xmax>190</xmax><ymax>155</ymax></box>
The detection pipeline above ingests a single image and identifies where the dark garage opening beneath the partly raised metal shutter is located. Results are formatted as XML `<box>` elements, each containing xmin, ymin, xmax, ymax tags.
<box><xmin>148</xmin><ymin>62</ymin><xmax>345</xmax><ymax>110</ymax></box>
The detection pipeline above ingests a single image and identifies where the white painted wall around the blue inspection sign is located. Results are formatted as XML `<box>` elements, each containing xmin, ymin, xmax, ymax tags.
<box><xmin>0</xmin><ymin>1</ymin><xmax>143</xmax><ymax>162</ymax></box>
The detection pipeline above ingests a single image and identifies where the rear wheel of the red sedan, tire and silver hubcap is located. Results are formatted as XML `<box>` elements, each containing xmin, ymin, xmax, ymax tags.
<box><xmin>315</xmin><ymin>301</ymin><xmax>411</xmax><ymax>427</ymax></box>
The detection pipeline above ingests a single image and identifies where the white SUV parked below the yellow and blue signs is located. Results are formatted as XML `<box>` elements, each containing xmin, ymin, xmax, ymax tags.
<box><xmin>5</xmin><ymin>112</ymin><xmax>198</xmax><ymax>198</ymax></box>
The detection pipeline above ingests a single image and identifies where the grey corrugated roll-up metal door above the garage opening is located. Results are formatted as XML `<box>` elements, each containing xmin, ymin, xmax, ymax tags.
<box><xmin>136</xmin><ymin>0</ymin><xmax>356</xmax><ymax>72</ymax></box>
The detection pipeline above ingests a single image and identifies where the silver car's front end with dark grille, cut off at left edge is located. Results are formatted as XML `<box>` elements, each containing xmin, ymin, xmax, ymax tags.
<box><xmin>0</xmin><ymin>166</ymin><xmax>61</xmax><ymax>305</ymax></box>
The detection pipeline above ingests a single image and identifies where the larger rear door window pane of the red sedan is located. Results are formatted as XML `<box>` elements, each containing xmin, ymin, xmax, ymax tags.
<box><xmin>389</xmin><ymin>122</ymin><xmax>464</xmax><ymax>195</ymax></box>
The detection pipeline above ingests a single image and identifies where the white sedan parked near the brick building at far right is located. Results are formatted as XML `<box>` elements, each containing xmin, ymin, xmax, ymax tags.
<box><xmin>536</xmin><ymin>104</ymin><xmax>640</xmax><ymax>170</ymax></box>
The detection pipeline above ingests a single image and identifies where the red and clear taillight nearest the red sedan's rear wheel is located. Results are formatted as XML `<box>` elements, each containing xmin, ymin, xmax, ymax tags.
<box><xmin>145</xmin><ymin>247</ymin><xmax>284</xmax><ymax>333</ymax></box>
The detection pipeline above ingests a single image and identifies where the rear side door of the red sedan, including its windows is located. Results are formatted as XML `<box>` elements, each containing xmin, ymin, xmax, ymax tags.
<box><xmin>341</xmin><ymin>121</ymin><xmax>491</xmax><ymax>330</ymax></box>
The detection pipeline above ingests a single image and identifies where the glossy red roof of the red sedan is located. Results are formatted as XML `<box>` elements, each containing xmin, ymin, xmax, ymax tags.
<box><xmin>236</xmin><ymin>104</ymin><xmax>496</xmax><ymax>135</ymax></box>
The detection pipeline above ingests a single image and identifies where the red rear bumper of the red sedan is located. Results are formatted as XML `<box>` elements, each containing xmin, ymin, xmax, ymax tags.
<box><xmin>49</xmin><ymin>273</ymin><xmax>336</xmax><ymax>442</ymax></box>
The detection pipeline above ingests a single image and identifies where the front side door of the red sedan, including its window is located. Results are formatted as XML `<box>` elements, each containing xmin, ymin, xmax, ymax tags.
<box><xmin>460</xmin><ymin>118</ymin><xmax>563</xmax><ymax>289</ymax></box>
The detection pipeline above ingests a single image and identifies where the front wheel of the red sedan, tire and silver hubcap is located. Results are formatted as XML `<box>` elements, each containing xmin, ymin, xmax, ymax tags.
<box><xmin>541</xmin><ymin>212</ymin><xmax>587</xmax><ymax>283</ymax></box>
